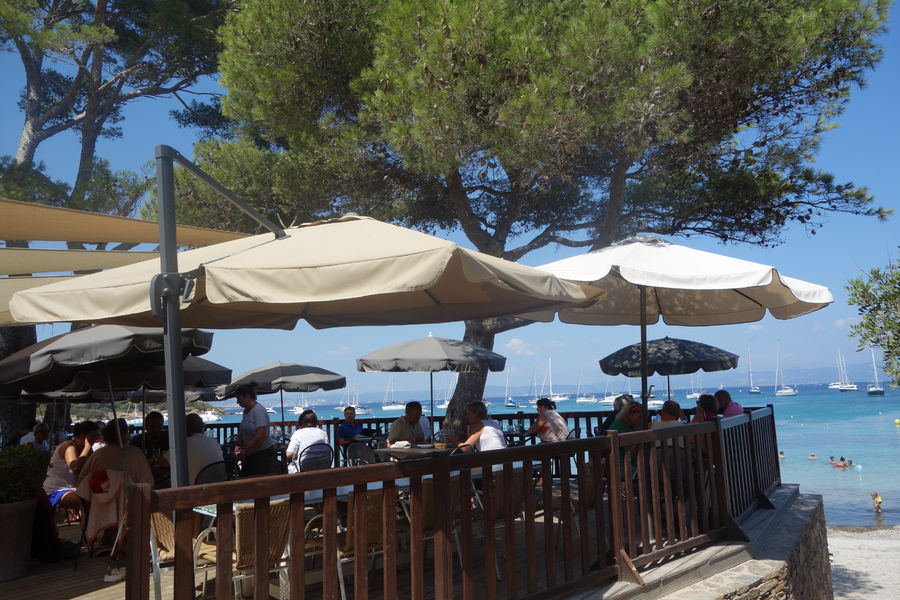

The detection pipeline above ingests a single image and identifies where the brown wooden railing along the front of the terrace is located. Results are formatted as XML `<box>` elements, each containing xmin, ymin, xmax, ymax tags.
<box><xmin>126</xmin><ymin>408</ymin><xmax>780</xmax><ymax>600</ymax></box>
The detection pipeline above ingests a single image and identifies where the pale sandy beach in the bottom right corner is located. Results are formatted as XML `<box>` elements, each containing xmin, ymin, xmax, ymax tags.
<box><xmin>828</xmin><ymin>526</ymin><xmax>900</xmax><ymax>600</ymax></box>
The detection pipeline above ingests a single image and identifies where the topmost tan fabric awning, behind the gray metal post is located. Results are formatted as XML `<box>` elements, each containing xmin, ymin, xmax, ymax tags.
<box><xmin>0</xmin><ymin>199</ymin><xmax>246</xmax><ymax>246</ymax></box>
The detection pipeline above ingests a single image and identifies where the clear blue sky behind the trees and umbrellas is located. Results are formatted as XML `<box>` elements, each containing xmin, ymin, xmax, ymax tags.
<box><xmin>0</xmin><ymin>14</ymin><xmax>900</xmax><ymax>394</ymax></box>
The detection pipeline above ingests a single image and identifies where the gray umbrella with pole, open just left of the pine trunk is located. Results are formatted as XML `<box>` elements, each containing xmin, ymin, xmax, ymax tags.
<box><xmin>356</xmin><ymin>335</ymin><xmax>506</xmax><ymax>419</ymax></box>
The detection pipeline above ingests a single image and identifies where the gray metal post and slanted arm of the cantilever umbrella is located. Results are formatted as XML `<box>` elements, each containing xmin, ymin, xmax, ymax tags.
<box><xmin>150</xmin><ymin>145</ymin><xmax>286</xmax><ymax>487</ymax></box>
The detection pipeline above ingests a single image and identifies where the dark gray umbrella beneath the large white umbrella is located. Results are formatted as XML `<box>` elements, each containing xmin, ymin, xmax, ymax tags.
<box><xmin>600</xmin><ymin>337</ymin><xmax>738</xmax><ymax>398</ymax></box>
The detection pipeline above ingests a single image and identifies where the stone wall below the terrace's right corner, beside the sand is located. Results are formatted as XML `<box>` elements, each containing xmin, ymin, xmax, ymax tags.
<box><xmin>720</xmin><ymin>499</ymin><xmax>834</xmax><ymax>600</ymax></box>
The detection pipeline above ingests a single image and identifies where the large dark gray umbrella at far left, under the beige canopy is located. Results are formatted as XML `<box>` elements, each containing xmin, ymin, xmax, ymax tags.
<box><xmin>0</xmin><ymin>325</ymin><xmax>213</xmax><ymax>395</ymax></box>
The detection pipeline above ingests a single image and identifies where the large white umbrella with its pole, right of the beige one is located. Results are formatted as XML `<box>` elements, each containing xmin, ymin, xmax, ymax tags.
<box><xmin>524</xmin><ymin>236</ymin><xmax>834</xmax><ymax>418</ymax></box>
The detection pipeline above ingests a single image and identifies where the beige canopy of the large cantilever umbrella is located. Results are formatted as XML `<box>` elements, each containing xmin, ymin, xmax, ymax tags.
<box><xmin>10</xmin><ymin>216</ymin><xmax>603</xmax><ymax>329</ymax></box>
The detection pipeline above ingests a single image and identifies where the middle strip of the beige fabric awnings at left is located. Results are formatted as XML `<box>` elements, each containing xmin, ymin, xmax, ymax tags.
<box><xmin>0</xmin><ymin>248</ymin><xmax>159</xmax><ymax>275</ymax></box>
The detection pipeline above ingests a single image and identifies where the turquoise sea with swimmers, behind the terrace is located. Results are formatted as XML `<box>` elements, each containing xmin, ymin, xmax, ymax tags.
<box><xmin>223</xmin><ymin>383</ymin><xmax>900</xmax><ymax>526</ymax></box>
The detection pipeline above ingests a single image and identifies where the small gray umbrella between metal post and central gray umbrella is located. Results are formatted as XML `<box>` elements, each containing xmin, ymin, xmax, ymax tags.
<box><xmin>216</xmin><ymin>362</ymin><xmax>347</xmax><ymax>428</ymax></box>
